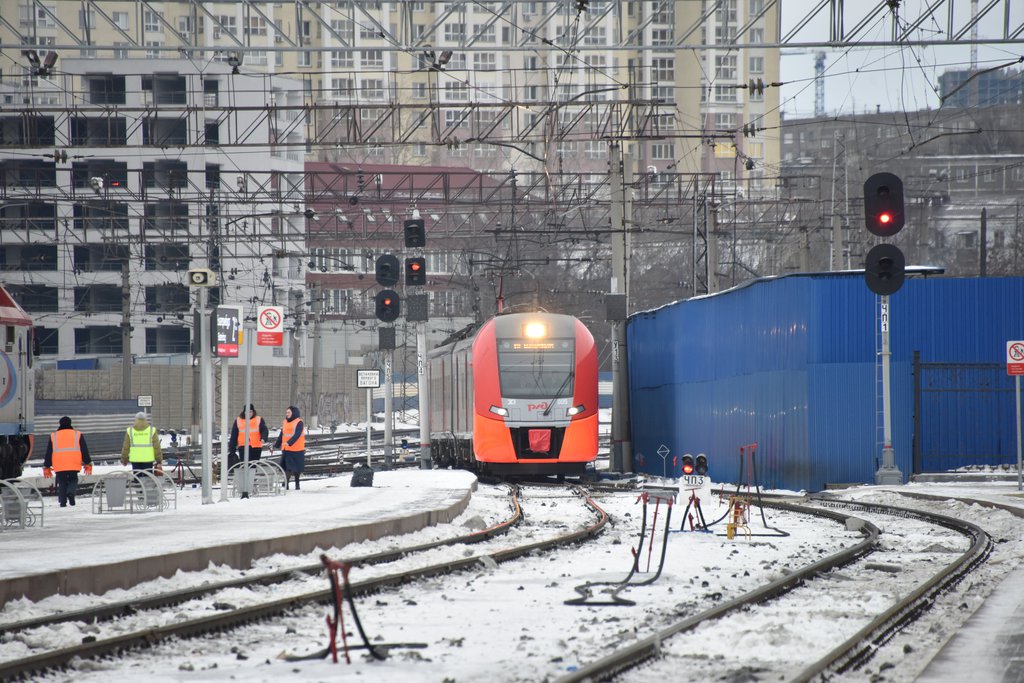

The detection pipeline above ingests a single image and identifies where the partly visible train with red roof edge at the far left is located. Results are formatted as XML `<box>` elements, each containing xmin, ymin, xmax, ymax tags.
<box><xmin>0</xmin><ymin>288</ymin><xmax>36</xmax><ymax>479</ymax></box>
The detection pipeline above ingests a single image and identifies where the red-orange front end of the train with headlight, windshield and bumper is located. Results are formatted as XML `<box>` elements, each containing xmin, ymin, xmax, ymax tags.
<box><xmin>473</xmin><ymin>313</ymin><xmax>598</xmax><ymax>474</ymax></box>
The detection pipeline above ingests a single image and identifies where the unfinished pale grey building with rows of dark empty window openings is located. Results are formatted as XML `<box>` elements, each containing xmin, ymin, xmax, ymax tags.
<box><xmin>0</xmin><ymin>58</ymin><xmax>306</xmax><ymax>362</ymax></box>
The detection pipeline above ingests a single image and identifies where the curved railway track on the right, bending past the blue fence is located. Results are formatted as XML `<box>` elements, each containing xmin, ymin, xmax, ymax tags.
<box><xmin>558</xmin><ymin>499</ymin><xmax>992</xmax><ymax>683</ymax></box>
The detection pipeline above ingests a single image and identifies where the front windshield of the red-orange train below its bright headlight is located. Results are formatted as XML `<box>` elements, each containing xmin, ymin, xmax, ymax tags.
<box><xmin>498</xmin><ymin>339</ymin><xmax>574</xmax><ymax>398</ymax></box>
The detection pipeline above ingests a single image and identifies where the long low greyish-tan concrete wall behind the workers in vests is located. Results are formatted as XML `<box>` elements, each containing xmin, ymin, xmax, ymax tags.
<box><xmin>36</xmin><ymin>366</ymin><xmax>366</xmax><ymax>431</ymax></box>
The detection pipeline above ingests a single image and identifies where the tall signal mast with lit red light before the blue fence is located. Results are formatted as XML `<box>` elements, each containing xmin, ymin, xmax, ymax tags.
<box><xmin>864</xmin><ymin>173</ymin><xmax>906</xmax><ymax>484</ymax></box>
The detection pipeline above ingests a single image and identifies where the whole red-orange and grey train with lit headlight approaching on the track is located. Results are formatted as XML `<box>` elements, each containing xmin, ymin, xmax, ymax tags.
<box><xmin>428</xmin><ymin>313</ymin><xmax>598</xmax><ymax>474</ymax></box>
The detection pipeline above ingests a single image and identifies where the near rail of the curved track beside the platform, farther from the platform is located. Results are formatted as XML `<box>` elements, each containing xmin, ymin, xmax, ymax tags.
<box><xmin>0</xmin><ymin>489</ymin><xmax>608</xmax><ymax>680</ymax></box>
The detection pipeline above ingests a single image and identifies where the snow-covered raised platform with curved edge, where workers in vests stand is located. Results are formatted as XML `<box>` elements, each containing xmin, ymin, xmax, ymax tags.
<box><xmin>0</xmin><ymin>468</ymin><xmax>476</xmax><ymax>605</ymax></box>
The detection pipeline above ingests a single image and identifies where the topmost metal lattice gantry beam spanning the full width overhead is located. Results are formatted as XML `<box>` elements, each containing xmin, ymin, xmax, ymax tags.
<box><xmin>0</xmin><ymin>0</ymin><xmax>1024</xmax><ymax>53</ymax></box>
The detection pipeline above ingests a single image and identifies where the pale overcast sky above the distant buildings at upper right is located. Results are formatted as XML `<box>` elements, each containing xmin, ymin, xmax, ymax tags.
<box><xmin>780</xmin><ymin>0</ymin><xmax>1024</xmax><ymax>119</ymax></box>
